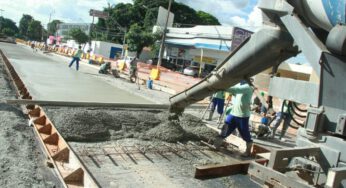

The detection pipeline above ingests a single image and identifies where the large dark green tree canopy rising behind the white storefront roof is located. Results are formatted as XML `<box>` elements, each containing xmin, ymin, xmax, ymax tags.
<box><xmin>94</xmin><ymin>0</ymin><xmax>220</xmax><ymax>43</ymax></box>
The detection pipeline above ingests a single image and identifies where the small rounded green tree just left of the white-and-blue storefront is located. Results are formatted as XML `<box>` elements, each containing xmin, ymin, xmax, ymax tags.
<box><xmin>126</xmin><ymin>24</ymin><xmax>155</xmax><ymax>57</ymax></box>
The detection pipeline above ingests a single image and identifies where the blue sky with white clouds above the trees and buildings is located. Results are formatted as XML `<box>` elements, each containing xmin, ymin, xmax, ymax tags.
<box><xmin>0</xmin><ymin>0</ymin><xmax>306</xmax><ymax>63</ymax></box>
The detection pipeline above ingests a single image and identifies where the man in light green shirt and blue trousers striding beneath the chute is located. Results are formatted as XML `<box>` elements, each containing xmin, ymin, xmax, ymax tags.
<box><xmin>214</xmin><ymin>80</ymin><xmax>253</xmax><ymax>157</ymax></box>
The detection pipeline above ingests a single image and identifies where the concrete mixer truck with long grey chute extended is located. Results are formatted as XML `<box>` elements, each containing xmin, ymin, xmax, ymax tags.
<box><xmin>170</xmin><ymin>0</ymin><xmax>346</xmax><ymax>187</ymax></box>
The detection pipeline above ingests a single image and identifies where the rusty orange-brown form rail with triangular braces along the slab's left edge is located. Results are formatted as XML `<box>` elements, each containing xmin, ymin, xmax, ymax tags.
<box><xmin>0</xmin><ymin>50</ymin><xmax>100</xmax><ymax>188</ymax></box>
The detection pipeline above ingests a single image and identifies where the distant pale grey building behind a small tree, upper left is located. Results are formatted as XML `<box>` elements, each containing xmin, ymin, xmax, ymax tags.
<box><xmin>56</xmin><ymin>23</ymin><xmax>91</xmax><ymax>42</ymax></box>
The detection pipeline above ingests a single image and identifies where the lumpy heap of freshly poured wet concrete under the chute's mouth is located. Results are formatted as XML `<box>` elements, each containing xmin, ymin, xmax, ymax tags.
<box><xmin>44</xmin><ymin>106</ymin><xmax>217</xmax><ymax>143</ymax></box>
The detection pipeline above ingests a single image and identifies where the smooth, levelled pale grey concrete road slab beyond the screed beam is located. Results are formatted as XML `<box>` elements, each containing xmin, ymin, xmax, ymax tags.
<box><xmin>0</xmin><ymin>43</ymin><xmax>152</xmax><ymax>104</ymax></box>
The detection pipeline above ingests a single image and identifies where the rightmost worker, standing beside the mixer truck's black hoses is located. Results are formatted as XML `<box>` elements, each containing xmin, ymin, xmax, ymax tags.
<box><xmin>272</xmin><ymin>100</ymin><xmax>292</xmax><ymax>141</ymax></box>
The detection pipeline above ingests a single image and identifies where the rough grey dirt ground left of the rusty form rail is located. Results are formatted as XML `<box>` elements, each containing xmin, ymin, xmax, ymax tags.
<box><xmin>0</xmin><ymin>54</ymin><xmax>60</xmax><ymax>187</ymax></box>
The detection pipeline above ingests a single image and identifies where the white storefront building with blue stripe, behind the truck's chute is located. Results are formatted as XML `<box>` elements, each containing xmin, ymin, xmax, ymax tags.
<box><xmin>153</xmin><ymin>26</ymin><xmax>251</xmax><ymax>73</ymax></box>
